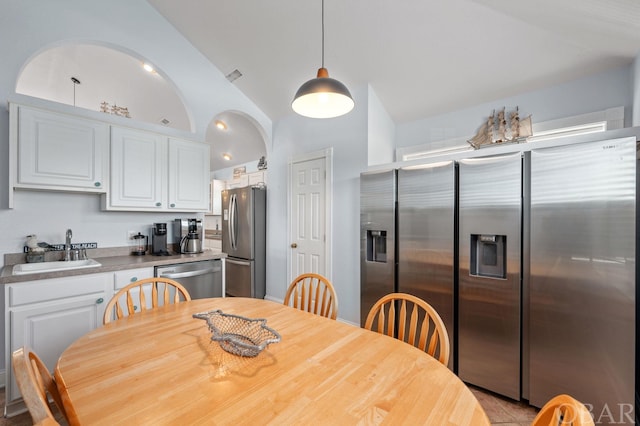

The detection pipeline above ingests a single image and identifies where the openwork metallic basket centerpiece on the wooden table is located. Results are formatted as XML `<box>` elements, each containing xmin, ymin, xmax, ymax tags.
<box><xmin>193</xmin><ymin>310</ymin><xmax>280</xmax><ymax>357</ymax></box>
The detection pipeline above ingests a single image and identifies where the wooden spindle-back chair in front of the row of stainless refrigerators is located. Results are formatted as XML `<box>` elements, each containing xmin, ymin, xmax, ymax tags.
<box><xmin>364</xmin><ymin>293</ymin><xmax>450</xmax><ymax>365</ymax></box>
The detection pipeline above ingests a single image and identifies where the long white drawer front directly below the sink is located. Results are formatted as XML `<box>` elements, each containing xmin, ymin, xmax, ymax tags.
<box><xmin>7</xmin><ymin>273</ymin><xmax>111</xmax><ymax>307</ymax></box>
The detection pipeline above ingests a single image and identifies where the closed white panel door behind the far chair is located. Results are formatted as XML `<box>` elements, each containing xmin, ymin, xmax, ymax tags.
<box><xmin>289</xmin><ymin>157</ymin><xmax>328</xmax><ymax>282</ymax></box>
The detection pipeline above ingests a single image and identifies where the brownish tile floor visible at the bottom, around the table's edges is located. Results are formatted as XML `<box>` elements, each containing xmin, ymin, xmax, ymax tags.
<box><xmin>0</xmin><ymin>386</ymin><xmax>538</xmax><ymax>426</ymax></box>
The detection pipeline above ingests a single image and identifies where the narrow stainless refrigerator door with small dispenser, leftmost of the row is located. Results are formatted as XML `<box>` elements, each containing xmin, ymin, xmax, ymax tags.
<box><xmin>360</xmin><ymin>170</ymin><xmax>397</xmax><ymax>326</ymax></box>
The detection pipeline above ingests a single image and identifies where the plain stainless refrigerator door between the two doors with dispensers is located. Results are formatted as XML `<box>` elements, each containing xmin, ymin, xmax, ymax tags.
<box><xmin>397</xmin><ymin>161</ymin><xmax>456</xmax><ymax>369</ymax></box>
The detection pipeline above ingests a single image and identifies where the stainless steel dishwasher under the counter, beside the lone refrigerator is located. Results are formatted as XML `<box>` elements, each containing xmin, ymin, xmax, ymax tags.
<box><xmin>154</xmin><ymin>259</ymin><xmax>222</xmax><ymax>299</ymax></box>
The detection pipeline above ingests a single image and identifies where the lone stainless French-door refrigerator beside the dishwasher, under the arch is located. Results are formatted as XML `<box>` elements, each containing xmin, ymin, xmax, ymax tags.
<box><xmin>222</xmin><ymin>187</ymin><xmax>267</xmax><ymax>299</ymax></box>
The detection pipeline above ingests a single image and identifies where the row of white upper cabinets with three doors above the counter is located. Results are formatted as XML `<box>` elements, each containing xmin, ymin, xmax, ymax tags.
<box><xmin>9</xmin><ymin>103</ymin><xmax>210</xmax><ymax>212</ymax></box>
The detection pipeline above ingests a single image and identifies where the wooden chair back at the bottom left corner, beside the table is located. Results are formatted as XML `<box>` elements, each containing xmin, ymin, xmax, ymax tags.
<box><xmin>11</xmin><ymin>347</ymin><xmax>68</xmax><ymax>425</ymax></box>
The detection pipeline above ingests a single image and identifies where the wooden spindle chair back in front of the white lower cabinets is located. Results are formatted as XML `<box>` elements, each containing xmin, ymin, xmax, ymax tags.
<box><xmin>102</xmin><ymin>277</ymin><xmax>191</xmax><ymax>324</ymax></box>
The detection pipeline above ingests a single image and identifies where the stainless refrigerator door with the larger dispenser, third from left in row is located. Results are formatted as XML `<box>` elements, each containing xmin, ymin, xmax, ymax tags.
<box><xmin>458</xmin><ymin>152</ymin><xmax>522</xmax><ymax>400</ymax></box>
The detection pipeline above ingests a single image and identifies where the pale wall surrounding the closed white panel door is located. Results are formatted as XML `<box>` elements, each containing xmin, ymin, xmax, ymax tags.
<box><xmin>267</xmin><ymin>87</ymin><xmax>367</xmax><ymax>323</ymax></box>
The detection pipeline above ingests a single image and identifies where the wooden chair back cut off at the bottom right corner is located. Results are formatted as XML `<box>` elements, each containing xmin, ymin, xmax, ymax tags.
<box><xmin>531</xmin><ymin>394</ymin><xmax>594</xmax><ymax>426</ymax></box>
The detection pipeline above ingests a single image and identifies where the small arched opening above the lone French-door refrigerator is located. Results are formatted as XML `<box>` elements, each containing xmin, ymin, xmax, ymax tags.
<box><xmin>205</xmin><ymin>110</ymin><xmax>268</xmax><ymax>171</ymax></box>
